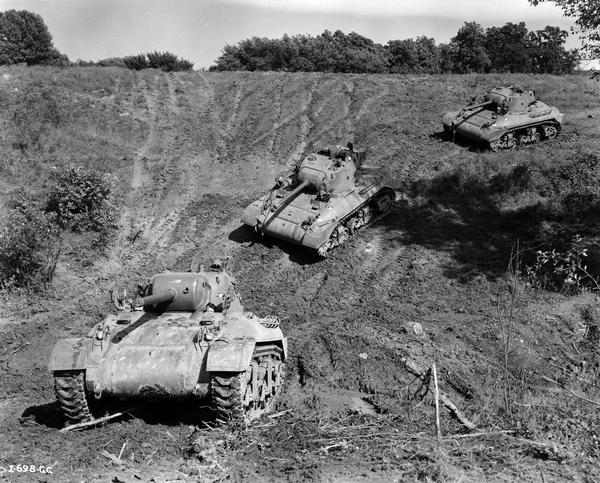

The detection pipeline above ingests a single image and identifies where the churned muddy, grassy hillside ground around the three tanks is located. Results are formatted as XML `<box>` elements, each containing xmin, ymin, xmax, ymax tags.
<box><xmin>0</xmin><ymin>68</ymin><xmax>600</xmax><ymax>481</ymax></box>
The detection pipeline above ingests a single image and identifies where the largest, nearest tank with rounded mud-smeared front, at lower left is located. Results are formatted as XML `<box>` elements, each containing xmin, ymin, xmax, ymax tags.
<box><xmin>49</xmin><ymin>264</ymin><xmax>287</xmax><ymax>424</ymax></box>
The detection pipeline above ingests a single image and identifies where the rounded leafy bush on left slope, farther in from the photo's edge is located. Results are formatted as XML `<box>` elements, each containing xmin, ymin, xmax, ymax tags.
<box><xmin>46</xmin><ymin>166</ymin><xmax>117</xmax><ymax>235</ymax></box>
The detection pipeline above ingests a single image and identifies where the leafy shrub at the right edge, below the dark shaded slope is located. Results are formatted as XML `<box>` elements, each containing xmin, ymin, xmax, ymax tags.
<box><xmin>525</xmin><ymin>235</ymin><xmax>600</xmax><ymax>294</ymax></box>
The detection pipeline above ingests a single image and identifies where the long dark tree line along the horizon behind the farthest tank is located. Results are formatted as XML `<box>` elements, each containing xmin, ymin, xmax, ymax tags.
<box><xmin>210</xmin><ymin>22</ymin><xmax>579</xmax><ymax>74</ymax></box>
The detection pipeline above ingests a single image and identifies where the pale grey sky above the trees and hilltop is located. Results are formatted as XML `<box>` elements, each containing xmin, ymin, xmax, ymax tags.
<box><xmin>0</xmin><ymin>0</ymin><xmax>578</xmax><ymax>68</ymax></box>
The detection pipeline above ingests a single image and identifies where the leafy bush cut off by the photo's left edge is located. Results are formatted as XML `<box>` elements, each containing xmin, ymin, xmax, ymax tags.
<box><xmin>0</xmin><ymin>196</ymin><xmax>60</xmax><ymax>288</ymax></box>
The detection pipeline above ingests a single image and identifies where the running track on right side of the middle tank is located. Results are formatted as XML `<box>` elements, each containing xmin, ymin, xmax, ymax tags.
<box><xmin>317</xmin><ymin>189</ymin><xmax>396</xmax><ymax>257</ymax></box>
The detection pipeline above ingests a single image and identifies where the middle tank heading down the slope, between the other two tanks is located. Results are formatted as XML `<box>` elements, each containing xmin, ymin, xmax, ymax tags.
<box><xmin>242</xmin><ymin>143</ymin><xmax>396</xmax><ymax>256</ymax></box>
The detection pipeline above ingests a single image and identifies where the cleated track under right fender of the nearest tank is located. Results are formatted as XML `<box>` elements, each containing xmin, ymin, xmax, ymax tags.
<box><xmin>210</xmin><ymin>345</ymin><xmax>285</xmax><ymax>424</ymax></box>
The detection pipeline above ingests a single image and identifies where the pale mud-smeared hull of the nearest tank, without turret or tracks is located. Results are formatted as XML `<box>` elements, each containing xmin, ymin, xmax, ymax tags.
<box><xmin>49</xmin><ymin>312</ymin><xmax>287</xmax><ymax>399</ymax></box>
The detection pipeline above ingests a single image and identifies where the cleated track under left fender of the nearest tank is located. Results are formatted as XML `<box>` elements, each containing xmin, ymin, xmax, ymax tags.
<box><xmin>54</xmin><ymin>371</ymin><xmax>94</xmax><ymax>424</ymax></box>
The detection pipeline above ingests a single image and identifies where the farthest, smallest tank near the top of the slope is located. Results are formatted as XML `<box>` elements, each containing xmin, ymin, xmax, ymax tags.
<box><xmin>442</xmin><ymin>86</ymin><xmax>563</xmax><ymax>151</ymax></box>
